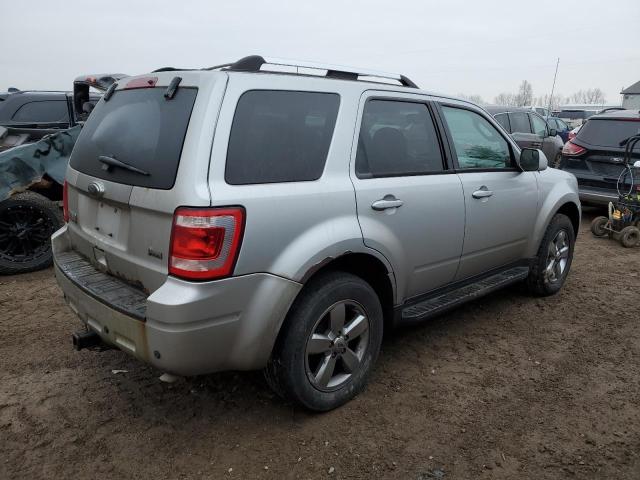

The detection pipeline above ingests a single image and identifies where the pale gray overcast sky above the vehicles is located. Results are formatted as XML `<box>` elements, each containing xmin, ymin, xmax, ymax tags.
<box><xmin>0</xmin><ymin>0</ymin><xmax>640</xmax><ymax>103</ymax></box>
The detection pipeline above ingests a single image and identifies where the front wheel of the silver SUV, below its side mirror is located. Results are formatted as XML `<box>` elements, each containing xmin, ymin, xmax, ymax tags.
<box><xmin>527</xmin><ymin>213</ymin><xmax>575</xmax><ymax>296</ymax></box>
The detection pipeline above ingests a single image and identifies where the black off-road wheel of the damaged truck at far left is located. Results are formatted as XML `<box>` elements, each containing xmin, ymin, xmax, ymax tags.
<box><xmin>0</xmin><ymin>191</ymin><xmax>64</xmax><ymax>275</ymax></box>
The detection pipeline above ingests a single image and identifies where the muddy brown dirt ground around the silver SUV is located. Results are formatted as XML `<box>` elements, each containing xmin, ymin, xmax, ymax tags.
<box><xmin>0</xmin><ymin>208</ymin><xmax>640</xmax><ymax>480</ymax></box>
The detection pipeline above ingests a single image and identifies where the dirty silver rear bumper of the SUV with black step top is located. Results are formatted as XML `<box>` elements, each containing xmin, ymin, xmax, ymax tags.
<box><xmin>52</xmin><ymin>227</ymin><xmax>302</xmax><ymax>375</ymax></box>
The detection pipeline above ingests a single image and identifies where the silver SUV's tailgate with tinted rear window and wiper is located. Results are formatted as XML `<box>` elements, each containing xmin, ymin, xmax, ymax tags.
<box><xmin>67</xmin><ymin>72</ymin><xmax>224</xmax><ymax>293</ymax></box>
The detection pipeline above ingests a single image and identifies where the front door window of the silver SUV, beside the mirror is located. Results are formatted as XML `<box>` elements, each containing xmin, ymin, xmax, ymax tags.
<box><xmin>442</xmin><ymin>107</ymin><xmax>511</xmax><ymax>168</ymax></box>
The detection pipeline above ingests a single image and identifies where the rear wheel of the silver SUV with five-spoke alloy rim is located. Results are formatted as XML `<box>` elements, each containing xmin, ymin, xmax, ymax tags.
<box><xmin>265</xmin><ymin>272</ymin><xmax>383</xmax><ymax>411</ymax></box>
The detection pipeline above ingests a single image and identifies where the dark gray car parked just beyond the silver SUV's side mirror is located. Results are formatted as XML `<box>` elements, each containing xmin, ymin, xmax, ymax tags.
<box><xmin>486</xmin><ymin>106</ymin><xmax>564</xmax><ymax>167</ymax></box>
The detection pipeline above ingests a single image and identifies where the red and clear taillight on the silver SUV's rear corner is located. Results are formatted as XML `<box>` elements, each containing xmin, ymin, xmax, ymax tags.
<box><xmin>169</xmin><ymin>207</ymin><xmax>244</xmax><ymax>280</ymax></box>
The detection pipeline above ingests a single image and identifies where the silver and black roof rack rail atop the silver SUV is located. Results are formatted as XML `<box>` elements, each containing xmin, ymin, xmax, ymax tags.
<box><xmin>203</xmin><ymin>55</ymin><xmax>418</xmax><ymax>88</ymax></box>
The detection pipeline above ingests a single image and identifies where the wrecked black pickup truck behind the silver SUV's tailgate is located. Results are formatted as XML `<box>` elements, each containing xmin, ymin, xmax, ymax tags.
<box><xmin>0</xmin><ymin>74</ymin><xmax>125</xmax><ymax>274</ymax></box>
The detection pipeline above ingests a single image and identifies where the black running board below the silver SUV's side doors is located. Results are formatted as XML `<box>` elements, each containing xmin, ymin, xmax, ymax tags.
<box><xmin>402</xmin><ymin>267</ymin><xmax>529</xmax><ymax>322</ymax></box>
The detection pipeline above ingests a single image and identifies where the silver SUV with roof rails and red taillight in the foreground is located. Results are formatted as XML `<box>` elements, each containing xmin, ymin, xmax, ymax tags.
<box><xmin>52</xmin><ymin>56</ymin><xmax>580</xmax><ymax>411</ymax></box>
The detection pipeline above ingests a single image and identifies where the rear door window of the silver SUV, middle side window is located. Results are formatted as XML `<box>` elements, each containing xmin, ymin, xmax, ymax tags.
<box><xmin>356</xmin><ymin>100</ymin><xmax>443</xmax><ymax>178</ymax></box>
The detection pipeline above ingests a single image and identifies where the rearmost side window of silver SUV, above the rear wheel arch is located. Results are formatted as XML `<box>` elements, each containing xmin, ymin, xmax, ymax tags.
<box><xmin>225</xmin><ymin>90</ymin><xmax>340</xmax><ymax>185</ymax></box>
